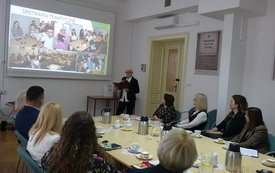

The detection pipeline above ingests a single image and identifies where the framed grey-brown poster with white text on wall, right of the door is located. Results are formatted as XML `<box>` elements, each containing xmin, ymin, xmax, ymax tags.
<box><xmin>195</xmin><ymin>31</ymin><xmax>221</xmax><ymax>75</ymax></box>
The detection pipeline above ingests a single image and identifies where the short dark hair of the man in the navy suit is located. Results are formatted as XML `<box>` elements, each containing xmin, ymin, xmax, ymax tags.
<box><xmin>26</xmin><ymin>86</ymin><xmax>44</xmax><ymax>102</ymax></box>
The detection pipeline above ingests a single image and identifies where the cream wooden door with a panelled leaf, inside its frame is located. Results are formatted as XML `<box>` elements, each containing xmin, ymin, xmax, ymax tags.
<box><xmin>146</xmin><ymin>39</ymin><xmax>184</xmax><ymax>117</ymax></box>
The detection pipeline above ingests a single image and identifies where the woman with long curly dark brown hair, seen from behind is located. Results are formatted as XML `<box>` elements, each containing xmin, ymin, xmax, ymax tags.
<box><xmin>42</xmin><ymin>111</ymin><xmax>124</xmax><ymax>173</ymax></box>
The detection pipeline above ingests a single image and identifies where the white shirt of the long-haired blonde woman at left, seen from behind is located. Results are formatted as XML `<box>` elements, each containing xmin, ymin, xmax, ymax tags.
<box><xmin>27</xmin><ymin>132</ymin><xmax>60</xmax><ymax>167</ymax></box>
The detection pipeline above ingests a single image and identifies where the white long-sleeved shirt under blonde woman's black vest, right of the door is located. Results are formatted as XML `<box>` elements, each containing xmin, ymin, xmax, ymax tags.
<box><xmin>178</xmin><ymin>111</ymin><xmax>207</xmax><ymax>129</ymax></box>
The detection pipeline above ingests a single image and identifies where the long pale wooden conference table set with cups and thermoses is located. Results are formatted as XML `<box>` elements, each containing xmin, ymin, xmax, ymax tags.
<box><xmin>94</xmin><ymin>116</ymin><xmax>275</xmax><ymax>173</ymax></box>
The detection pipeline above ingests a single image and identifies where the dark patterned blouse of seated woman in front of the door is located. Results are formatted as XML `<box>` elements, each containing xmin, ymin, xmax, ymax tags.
<box><xmin>154</xmin><ymin>104</ymin><xmax>176</xmax><ymax>124</ymax></box>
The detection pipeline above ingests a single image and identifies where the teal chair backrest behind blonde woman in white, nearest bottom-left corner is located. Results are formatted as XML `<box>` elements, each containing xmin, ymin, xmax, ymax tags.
<box><xmin>17</xmin><ymin>146</ymin><xmax>43</xmax><ymax>173</ymax></box>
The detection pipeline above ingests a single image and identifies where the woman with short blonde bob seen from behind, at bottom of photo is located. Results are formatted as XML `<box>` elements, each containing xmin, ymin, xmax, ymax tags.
<box><xmin>130</xmin><ymin>128</ymin><xmax>198</xmax><ymax>173</ymax></box>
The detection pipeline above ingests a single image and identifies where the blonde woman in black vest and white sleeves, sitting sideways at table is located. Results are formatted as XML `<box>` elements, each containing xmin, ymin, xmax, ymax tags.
<box><xmin>176</xmin><ymin>93</ymin><xmax>207</xmax><ymax>131</ymax></box>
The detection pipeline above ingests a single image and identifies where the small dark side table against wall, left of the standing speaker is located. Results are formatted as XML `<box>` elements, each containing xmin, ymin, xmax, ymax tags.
<box><xmin>86</xmin><ymin>96</ymin><xmax>119</xmax><ymax>116</ymax></box>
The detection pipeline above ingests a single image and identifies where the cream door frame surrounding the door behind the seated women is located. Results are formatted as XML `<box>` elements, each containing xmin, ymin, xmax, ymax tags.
<box><xmin>143</xmin><ymin>32</ymin><xmax>188</xmax><ymax>116</ymax></box>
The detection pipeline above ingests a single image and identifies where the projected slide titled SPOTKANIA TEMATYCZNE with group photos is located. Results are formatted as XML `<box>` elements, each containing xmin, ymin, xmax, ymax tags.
<box><xmin>8</xmin><ymin>6</ymin><xmax>110</xmax><ymax>74</ymax></box>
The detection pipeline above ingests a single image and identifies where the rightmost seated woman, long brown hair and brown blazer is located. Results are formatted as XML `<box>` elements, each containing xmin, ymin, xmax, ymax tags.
<box><xmin>231</xmin><ymin>107</ymin><xmax>269</xmax><ymax>154</ymax></box>
